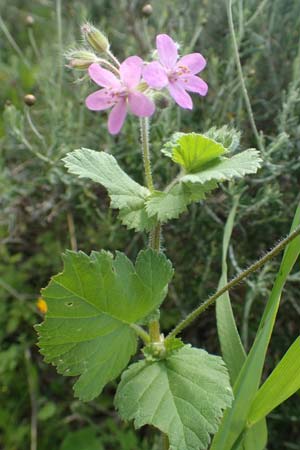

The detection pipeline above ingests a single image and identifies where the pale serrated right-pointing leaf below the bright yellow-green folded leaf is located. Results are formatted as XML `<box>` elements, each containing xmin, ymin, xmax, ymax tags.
<box><xmin>181</xmin><ymin>149</ymin><xmax>261</xmax><ymax>184</ymax></box>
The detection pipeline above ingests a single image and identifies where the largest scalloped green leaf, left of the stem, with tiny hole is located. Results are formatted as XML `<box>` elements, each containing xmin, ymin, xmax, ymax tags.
<box><xmin>37</xmin><ymin>249</ymin><xmax>173</xmax><ymax>400</ymax></box>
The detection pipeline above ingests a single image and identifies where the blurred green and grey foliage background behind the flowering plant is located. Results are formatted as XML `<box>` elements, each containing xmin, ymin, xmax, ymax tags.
<box><xmin>0</xmin><ymin>0</ymin><xmax>300</xmax><ymax>450</ymax></box>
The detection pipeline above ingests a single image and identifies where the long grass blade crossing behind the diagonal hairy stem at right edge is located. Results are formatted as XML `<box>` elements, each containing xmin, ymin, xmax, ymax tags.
<box><xmin>211</xmin><ymin>205</ymin><xmax>300</xmax><ymax>450</ymax></box>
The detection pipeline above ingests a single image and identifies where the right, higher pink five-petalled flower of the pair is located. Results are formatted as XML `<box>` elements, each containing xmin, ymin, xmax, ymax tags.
<box><xmin>143</xmin><ymin>34</ymin><xmax>208</xmax><ymax>109</ymax></box>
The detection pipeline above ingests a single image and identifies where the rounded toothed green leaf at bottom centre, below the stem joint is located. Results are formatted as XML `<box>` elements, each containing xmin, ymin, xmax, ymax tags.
<box><xmin>115</xmin><ymin>346</ymin><xmax>232</xmax><ymax>450</ymax></box>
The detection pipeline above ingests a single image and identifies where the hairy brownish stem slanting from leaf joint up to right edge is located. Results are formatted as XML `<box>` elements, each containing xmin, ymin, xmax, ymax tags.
<box><xmin>166</xmin><ymin>226</ymin><xmax>300</xmax><ymax>339</ymax></box>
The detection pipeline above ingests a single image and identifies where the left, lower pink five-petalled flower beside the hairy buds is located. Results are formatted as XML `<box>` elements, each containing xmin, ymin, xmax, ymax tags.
<box><xmin>85</xmin><ymin>56</ymin><xmax>155</xmax><ymax>134</ymax></box>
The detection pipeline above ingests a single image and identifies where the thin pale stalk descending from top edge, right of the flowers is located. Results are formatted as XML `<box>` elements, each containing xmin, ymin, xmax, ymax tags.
<box><xmin>227</xmin><ymin>0</ymin><xmax>264</xmax><ymax>152</ymax></box>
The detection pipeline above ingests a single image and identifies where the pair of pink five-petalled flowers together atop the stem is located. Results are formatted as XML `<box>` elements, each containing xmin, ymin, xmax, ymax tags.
<box><xmin>73</xmin><ymin>34</ymin><xmax>208</xmax><ymax>134</ymax></box>
